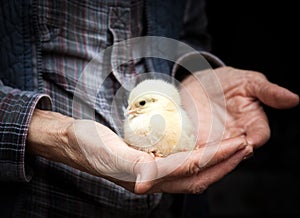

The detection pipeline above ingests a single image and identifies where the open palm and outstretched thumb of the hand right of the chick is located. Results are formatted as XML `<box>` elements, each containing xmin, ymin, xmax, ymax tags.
<box><xmin>182</xmin><ymin>67</ymin><xmax>299</xmax><ymax>148</ymax></box>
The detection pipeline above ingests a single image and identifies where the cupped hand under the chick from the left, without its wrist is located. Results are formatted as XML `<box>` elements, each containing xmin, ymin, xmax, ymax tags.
<box><xmin>67</xmin><ymin>116</ymin><xmax>251</xmax><ymax>194</ymax></box>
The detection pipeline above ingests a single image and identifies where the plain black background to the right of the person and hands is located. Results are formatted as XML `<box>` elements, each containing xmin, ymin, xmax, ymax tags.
<box><xmin>207</xmin><ymin>0</ymin><xmax>300</xmax><ymax>217</ymax></box>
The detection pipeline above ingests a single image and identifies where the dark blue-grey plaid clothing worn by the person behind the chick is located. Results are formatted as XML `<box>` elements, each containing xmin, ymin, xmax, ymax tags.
<box><xmin>0</xmin><ymin>0</ymin><xmax>221</xmax><ymax>217</ymax></box>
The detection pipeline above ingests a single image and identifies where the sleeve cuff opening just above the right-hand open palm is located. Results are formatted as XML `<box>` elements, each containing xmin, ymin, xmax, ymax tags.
<box><xmin>172</xmin><ymin>51</ymin><xmax>225</xmax><ymax>81</ymax></box>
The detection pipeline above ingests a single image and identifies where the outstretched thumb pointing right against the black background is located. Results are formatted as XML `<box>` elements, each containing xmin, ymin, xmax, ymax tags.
<box><xmin>253</xmin><ymin>80</ymin><xmax>299</xmax><ymax>109</ymax></box>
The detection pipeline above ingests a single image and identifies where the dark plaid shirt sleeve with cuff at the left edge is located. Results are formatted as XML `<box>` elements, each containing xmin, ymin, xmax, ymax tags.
<box><xmin>0</xmin><ymin>81</ymin><xmax>51</xmax><ymax>182</ymax></box>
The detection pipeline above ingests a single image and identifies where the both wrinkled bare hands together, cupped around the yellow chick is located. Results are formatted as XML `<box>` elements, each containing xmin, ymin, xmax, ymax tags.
<box><xmin>27</xmin><ymin>67</ymin><xmax>299</xmax><ymax>194</ymax></box>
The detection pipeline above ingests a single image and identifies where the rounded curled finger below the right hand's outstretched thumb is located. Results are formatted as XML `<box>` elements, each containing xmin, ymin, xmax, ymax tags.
<box><xmin>246</xmin><ymin>119</ymin><xmax>271</xmax><ymax>148</ymax></box>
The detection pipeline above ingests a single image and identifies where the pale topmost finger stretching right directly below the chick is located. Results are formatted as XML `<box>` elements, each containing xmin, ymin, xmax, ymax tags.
<box><xmin>157</xmin><ymin>136</ymin><xmax>247</xmax><ymax>179</ymax></box>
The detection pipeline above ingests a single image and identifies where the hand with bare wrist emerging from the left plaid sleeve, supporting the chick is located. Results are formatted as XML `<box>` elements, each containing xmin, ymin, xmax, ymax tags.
<box><xmin>27</xmin><ymin>109</ymin><xmax>251</xmax><ymax>194</ymax></box>
